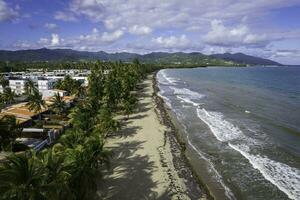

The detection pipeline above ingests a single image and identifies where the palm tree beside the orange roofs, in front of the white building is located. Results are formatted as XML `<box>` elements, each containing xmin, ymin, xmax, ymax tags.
<box><xmin>26</xmin><ymin>91</ymin><xmax>46</xmax><ymax>120</ymax></box>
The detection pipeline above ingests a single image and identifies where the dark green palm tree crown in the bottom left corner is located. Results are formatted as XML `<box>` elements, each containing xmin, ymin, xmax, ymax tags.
<box><xmin>0</xmin><ymin>153</ymin><xmax>45</xmax><ymax>199</ymax></box>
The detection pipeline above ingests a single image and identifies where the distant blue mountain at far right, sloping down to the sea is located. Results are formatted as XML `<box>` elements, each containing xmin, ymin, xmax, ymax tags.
<box><xmin>210</xmin><ymin>53</ymin><xmax>282</xmax><ymax>65</ymax></box>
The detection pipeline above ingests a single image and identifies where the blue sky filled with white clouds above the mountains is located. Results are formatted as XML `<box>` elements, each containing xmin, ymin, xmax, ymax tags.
<box><xmin>0</xmin><ymin>0</ymin><xmax>300</xmax><ymax>64</ymax></box>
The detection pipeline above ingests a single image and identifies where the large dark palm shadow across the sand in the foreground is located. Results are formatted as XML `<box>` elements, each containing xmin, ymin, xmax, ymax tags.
<box><xmin>97</xmin><ymin>141</ymin><xmax>170</xmax><ymax>200</ymax></box>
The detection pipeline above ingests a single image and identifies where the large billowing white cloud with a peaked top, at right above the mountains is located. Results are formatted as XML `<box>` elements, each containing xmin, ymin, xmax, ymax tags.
<box><xmin>203</xmin><ymin>20</ymin><xmax>268</xmax><ymax>47</ymax></box>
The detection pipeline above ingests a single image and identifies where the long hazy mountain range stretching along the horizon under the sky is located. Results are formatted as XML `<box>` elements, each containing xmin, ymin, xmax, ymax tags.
<box><xmin>0</xmin><ymin>48</ymin><xmax>280</xmax><ymax>66</ymax></box>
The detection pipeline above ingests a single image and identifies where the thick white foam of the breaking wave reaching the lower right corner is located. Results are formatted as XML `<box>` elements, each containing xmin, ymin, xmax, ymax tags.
<box><xmin>197</xmin><ymin>108</ymin><xmax>300</xmax><ymax>199</ymax></box>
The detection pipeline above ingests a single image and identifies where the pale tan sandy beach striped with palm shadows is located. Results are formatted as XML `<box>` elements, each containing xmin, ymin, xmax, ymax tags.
<box><xmin>98</xmin><ymin>75</ymin><xmax>206</xmax><ymax>200</ymax></box>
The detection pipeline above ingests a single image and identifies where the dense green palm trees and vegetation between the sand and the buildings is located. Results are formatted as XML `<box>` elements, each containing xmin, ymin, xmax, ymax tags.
<box><xmin>0</xmin><ymin>60</ymin><xmax>159</xmax><ymax>200</ymax></box>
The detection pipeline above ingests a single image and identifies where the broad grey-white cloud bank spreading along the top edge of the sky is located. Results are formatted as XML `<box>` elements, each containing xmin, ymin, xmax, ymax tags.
<box><xmin>53</xmin><ymin>0</ymin><xmax>300</xmax><ymax>34</ymax></box>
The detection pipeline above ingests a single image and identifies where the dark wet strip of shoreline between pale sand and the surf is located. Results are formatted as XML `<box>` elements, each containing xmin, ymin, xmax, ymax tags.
<box><xmin>152</xmin><ymin>71</ymin><xmax>234</xmax><ymax>200</ymax></box>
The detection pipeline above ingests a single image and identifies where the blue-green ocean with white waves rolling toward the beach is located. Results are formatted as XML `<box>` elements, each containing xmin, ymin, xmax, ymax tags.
<box><xmin>157</xmin><ymin>66</ymin><xmax>300</xmax><ymax>200</ymax></box>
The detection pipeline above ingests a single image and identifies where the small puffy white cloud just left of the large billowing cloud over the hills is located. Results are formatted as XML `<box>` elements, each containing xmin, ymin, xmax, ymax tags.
<box><xmin>152</xmin><ymin>35</ymin><xmax>190</xmax><ymax>49</ymax></box>
